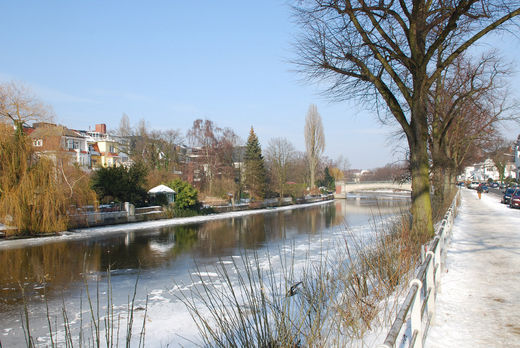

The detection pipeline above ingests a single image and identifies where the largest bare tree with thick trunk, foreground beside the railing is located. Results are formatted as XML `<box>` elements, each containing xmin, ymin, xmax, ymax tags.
<box><xmin>295</xmin><ymin>0</ymin><xmax>520</xmax><ymax>241</ymax></box>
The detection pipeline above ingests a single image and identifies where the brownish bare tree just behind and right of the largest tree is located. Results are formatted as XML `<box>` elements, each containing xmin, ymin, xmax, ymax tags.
<box><xmin>428</xmin><ymin>53</ymin><xmax>518</xmax><ymax>202</ymax></box>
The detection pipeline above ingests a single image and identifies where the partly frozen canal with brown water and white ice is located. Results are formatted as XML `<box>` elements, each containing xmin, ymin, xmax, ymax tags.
<box><xmin>0</xmin><ymin>193</ymin><xmax>409</xmax><ymax>347</ymax></box>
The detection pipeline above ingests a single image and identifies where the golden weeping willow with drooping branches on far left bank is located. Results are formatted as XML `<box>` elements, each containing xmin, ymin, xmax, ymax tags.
<box><xmin>0</xmin><ymin>125</ymin><xmax>68</xmax><ymax>234</ymax></box>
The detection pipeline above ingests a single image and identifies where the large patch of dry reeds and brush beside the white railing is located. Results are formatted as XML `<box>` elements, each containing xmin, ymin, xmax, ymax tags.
<box><xmin>180</xmin><ymin>208</ymin><xmax>419</xmax><ymax>348</ymax></box>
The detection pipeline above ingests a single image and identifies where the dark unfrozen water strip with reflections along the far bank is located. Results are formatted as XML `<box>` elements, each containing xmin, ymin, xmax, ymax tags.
<box><xmin>0</xmin><ymin>197</ymin><xmax>409</xmax><ymax>312</ymax></box>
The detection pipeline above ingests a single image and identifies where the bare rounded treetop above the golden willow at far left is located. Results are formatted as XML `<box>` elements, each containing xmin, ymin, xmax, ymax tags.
<box><xmin>0</xmin><ymin>82</ymin><xmax>53</xmax><ymax>130</ymax></box>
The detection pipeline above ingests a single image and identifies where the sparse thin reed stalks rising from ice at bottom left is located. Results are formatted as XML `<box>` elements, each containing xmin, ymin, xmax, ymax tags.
<box><xmin>22</xmin><ymin>270</ymin><xmax>148</xmax><ymax>348</ymax></box>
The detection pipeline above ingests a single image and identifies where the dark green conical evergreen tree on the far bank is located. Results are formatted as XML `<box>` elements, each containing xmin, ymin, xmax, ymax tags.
<box><xmin>244</xmin><ymin>127</ymin><xmax>267</xmax><ymax>200</ymax></box>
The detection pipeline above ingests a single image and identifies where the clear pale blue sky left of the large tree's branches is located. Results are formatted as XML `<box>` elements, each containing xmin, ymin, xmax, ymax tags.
<box><xmin>0</xmin><ymin>0</ymin><xmax>519</xmax><ymax>168</ymax></box>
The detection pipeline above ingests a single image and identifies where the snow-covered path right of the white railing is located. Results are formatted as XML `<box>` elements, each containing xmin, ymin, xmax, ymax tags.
<box><xmin>425</xmin><ymin>189</ymin><xmax>520</xmax><ymax>348</ymax></box>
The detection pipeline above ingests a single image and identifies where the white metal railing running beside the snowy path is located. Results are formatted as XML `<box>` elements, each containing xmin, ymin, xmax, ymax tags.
<box><xmin>378</xmin><ymin>190</ymin><xmax>460</xmax><ymax>348</ymax></box>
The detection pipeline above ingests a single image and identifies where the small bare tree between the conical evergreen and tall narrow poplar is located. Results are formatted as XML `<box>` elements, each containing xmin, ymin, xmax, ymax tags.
<box><xmin>266</xmin><ymin>138</ymin><xmax>295</xmax><ymax>199</ymax></box>
